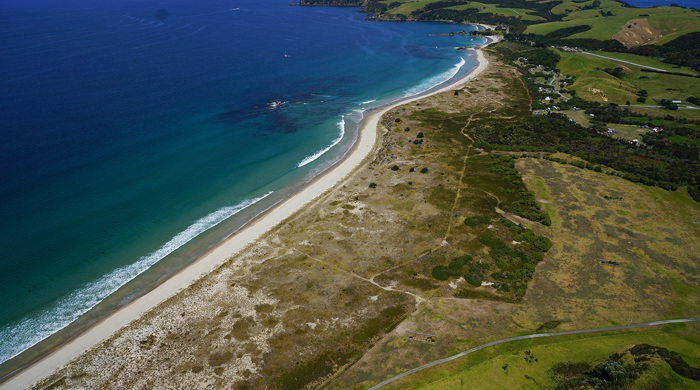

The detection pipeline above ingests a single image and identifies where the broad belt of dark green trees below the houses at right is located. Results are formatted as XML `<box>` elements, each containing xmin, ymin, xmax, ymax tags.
<box><xmin>472</xmin><ymin>114</ymin><xmax>700</xmax><ymax>201</ymax></box>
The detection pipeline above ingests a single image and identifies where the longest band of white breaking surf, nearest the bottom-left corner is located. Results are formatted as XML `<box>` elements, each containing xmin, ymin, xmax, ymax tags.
<box><xmin>0</xmin><ymin>191</ymin><xmax>272</xmax><ymax>363</ymax></box>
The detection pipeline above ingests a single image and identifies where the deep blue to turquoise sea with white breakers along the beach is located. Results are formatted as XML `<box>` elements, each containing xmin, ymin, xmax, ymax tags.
<box><xmin>0</xmin><ymin>0</ymin><xmax>482</xmax><ymax>362</ymax></box>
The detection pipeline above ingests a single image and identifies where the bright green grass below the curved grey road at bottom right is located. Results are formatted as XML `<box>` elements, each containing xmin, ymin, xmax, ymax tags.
<box><xmin>389</xmin><ymin>329</ymin><xmax>699</xmax><ymax>389</ymax></box>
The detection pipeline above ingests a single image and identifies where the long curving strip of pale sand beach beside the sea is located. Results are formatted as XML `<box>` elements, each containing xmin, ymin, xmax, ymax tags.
<box><xmin>0</xmin><ymin>37</ymin><xmax>500</xmax><ymax>389</ymax></box>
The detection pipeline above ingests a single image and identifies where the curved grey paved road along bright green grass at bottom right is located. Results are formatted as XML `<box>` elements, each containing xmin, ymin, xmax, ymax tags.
<box><xmin>368</xmin><ymin>318</ymin><xmax>700</xmax><ymax>390</ymax></box>
